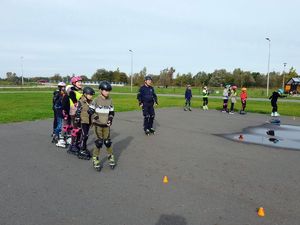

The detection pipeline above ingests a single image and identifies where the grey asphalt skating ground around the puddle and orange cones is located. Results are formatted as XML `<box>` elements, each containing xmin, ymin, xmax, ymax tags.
<box><xmin>0</xmin><ymin>108</ymin><xmax>300</xmax><ymax>225</ymax></box>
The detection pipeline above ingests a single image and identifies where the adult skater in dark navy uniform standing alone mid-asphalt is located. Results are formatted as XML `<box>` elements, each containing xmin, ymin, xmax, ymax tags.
<box><xmin>137</xmin><ymin>75</ymin><xmax>158</xmax><ymax>135</ymax></box>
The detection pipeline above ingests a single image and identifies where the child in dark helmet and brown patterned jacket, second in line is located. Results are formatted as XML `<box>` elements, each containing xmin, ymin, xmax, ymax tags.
<box><xmin>75</xmin><ymin>87</ymin><xmax>95</xmax><ymax>160</ymax></box>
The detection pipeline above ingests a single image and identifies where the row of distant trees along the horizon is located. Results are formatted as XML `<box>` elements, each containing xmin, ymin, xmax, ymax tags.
<box><xmin>0</xmin><ymin>67</ymin><xmax>298</xmax><ymax>88</ymax></box>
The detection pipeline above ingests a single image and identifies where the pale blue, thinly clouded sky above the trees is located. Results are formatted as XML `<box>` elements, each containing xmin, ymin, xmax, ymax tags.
<box><xmin>0</xmin><ymin>0</ymin><xmax>300</xmax><ymax>78</ymax></box>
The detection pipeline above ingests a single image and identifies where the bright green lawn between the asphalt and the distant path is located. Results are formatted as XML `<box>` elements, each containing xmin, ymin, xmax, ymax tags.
<box><xmin>0</xmin><ymin>91</ymin><xmax>300</xmax><ymax>123</ymax></box>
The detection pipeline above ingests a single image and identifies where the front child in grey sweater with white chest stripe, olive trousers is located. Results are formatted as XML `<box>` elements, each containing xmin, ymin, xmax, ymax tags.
<box><xmin>88</xmin><ymin>81</ymin><xmax>116</xmax><ymax>171</ymax></box>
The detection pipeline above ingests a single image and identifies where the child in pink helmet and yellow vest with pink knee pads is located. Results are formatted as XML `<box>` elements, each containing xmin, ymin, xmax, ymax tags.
<box><xmin>67</xmin><ymin>76</ymin><xmax>82</xmax><ymax>155</ymax></box>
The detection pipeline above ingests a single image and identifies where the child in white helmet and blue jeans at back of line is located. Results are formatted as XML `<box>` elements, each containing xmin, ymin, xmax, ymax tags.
<box><xmin>52</xmin><ymin>82</ymin><xmax>66</xmax><ymax>143</ymax></box>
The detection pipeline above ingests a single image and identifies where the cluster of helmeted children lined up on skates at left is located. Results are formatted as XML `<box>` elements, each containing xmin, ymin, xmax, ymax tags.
<box><xmin>52</xmin><ymin>76</ymin><xmax>116</xmax><ymax>171</ymax></box>
